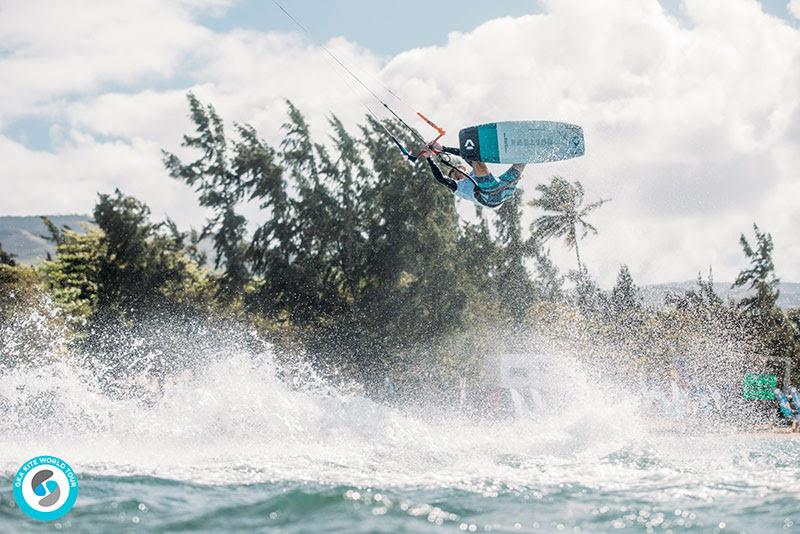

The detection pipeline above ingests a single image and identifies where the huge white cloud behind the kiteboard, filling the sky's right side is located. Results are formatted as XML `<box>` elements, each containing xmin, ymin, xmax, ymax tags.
<box><xmin>385</xmin><ymin>1</ymin><xmax>800</xmax><ymax>283</ymax></box>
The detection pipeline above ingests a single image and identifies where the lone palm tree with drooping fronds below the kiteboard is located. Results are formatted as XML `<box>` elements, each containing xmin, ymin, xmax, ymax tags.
<box><xmin>530</xmin><ymin>176</ymin><xmax>609</xmax><ymax>272</ymax></box>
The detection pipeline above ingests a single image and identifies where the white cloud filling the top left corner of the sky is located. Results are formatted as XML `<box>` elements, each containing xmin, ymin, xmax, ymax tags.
<box><xmin>0</xmin><ymin>0</ymin><xmax>213</xmax><ymax>122</ymax></box>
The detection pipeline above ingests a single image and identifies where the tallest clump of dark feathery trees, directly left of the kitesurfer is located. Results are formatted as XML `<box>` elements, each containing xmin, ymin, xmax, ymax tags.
<box><xmin>164</xmin><ymin>95</ymin><xmax>482</xmax><ymax>382</ymax></box>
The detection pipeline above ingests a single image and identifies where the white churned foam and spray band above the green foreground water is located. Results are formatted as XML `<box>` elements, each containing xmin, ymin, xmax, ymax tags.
<box><xmin>0</xmin><ymin>338</ymin><xmax>800</xmax><ymax>499</ymax></box>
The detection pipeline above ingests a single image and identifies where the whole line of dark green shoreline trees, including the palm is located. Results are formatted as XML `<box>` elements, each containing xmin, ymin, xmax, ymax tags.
<box><xmin>9</xmin><ymin>94</ymin><xmax>800</xmax><ymax>398</ymax></box>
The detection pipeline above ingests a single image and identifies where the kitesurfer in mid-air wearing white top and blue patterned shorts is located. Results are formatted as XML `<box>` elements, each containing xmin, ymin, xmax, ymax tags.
<box><xmin>420</xmin><ymin>145</ymin><xmax>525</xmax><ymax>208</ymax></box>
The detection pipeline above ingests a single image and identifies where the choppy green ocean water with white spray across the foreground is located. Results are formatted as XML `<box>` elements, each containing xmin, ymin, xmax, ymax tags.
<box><xmin>0</xmin><ymin>352</ymin><xmax>800</xmax><ymax>533</ymax></box>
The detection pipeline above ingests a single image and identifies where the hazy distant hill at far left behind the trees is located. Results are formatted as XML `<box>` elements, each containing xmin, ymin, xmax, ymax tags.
<box><xmin>0</xmin><ymin>215</ymin><xmax>92</xmax><ymax>263</ymax></box>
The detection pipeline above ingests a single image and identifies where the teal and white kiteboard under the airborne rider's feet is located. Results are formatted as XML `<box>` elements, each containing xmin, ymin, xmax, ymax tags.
<box><xmin>458</xmin><ymin>121</ymin><xmax>584</xmax><ymax>163</ymax></box>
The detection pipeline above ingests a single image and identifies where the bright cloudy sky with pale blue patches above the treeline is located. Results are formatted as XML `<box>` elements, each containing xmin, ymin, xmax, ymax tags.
<box><xmin>0</xmin><ymin>0</ymin><xmax>800</xmax><ymax>286</ymax></box>
